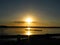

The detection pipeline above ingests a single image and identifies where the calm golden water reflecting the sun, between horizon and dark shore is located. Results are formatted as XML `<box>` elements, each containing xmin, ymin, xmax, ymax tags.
<box><xmin>0</xmin><ymin>28</ymin><xmax>60</xmax><ymax>35</ymax></box>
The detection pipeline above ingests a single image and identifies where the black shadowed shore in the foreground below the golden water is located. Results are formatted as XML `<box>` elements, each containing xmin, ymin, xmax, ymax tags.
<box><xmin>0</xmin><ymin>34</ymin><xmax>60</xmax><ymax>45</ymax></box>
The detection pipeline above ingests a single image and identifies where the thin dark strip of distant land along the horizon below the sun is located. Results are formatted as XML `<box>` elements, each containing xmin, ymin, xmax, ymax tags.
<box><xmin>0</xmin><ymin>26</ymin><xmax>60</xmax><ymax>28</ymax></box>
